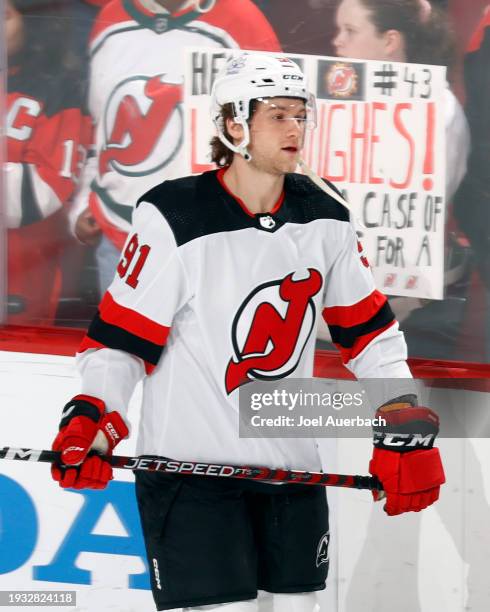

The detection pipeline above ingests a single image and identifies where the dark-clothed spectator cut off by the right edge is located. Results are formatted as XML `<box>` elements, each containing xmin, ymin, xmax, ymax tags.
<box><xmin>454</xmin><ymin>5</ymin><xmax>490</xmax><ymax>362</ymax></box>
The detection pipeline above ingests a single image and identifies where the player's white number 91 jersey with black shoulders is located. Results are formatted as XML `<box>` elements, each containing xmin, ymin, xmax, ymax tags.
<box><xmin>78</xmin><ymin>169</ymin><xmax>410</xmax><ymax>469</ymax></box>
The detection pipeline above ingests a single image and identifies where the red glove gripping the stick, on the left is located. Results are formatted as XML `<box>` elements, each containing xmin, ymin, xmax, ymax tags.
<box><xmin>51</xmin><ymin>395</ymin><xmax>129</xmax><ymax>489</ymax></box>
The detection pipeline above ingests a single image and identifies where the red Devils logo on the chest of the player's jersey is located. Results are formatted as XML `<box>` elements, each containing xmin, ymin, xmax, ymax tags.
<box><xmin>225</xmin><ymin>268</ymin><xmax>322</xmax><ymax>393</ymax></box>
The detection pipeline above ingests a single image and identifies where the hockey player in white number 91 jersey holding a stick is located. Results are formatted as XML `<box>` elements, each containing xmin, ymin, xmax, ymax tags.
<box><xmin>53</xmin><ymin>53</ymin><xmax>444</xmax><ymax>612</ymax></box>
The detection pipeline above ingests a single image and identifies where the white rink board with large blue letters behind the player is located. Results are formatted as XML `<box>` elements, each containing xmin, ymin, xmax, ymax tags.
<box><xmin>0</xmin><ymin>352</ymin><xmax>490</xmax><ymax>612</ymax></box>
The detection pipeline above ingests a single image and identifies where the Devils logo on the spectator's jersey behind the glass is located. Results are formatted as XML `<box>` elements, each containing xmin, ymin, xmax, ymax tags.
<box><xmin>99</xmin><ymin>75</ymin><xmax>183</xmax><ymax>177</ymax></box>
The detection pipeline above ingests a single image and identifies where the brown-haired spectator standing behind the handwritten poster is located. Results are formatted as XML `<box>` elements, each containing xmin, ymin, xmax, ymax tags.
<box><xmin>322</xmin><ymin>0</ymin><xmax>470</xmax><ymax>359</ymax></box>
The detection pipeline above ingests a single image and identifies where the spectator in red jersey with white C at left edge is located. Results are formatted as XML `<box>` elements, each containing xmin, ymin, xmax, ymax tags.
<box><xmin>3</xmin><ymin>0</ymin><xmax>90</xmax><ymax>325</ymax></box>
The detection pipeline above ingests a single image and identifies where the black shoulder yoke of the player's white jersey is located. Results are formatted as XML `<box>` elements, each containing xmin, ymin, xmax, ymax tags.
<box><xmin>137</xmin><ymin>170</ymin><xmax>349</xmax><ymax>246</ymax></box>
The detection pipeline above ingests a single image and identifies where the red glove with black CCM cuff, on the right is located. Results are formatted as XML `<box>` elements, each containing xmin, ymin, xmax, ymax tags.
<box><xmin>369</xmin><ymin>402</ymin><xmax>445</xmax><ymax>516</ymax></box>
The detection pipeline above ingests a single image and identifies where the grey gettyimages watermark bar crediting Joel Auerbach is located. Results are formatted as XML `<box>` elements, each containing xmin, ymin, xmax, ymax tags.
<box><xmin>239</xmin><ymin>378</ymin><xmax>490</xmax><ymax>438</ymax></box>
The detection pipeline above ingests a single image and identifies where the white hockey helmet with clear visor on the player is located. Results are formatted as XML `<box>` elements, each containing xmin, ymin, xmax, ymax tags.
<box><xmin>211</xmin><ymin>52</ymin><xmax>316</xmax><ymax>161</ymax></box>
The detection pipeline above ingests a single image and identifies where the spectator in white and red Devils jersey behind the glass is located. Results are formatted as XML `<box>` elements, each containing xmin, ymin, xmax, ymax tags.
<box><xmin>72</xmin><ymin>0</ymin><xmax>280</xmax><ymax>293</ymax></box>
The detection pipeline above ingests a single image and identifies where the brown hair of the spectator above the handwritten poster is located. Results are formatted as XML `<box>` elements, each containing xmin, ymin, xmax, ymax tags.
<box><xmin>359</xmin><ymin>0</ymin><xmax>456</xmax><ymax>73</ymax></box>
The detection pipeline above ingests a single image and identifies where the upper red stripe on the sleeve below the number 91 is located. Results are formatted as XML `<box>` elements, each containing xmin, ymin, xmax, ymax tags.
<box><xmin>99</xmin><ymin>291</ymin><xmax>170</xmax><ymax>346</ymax></box>
